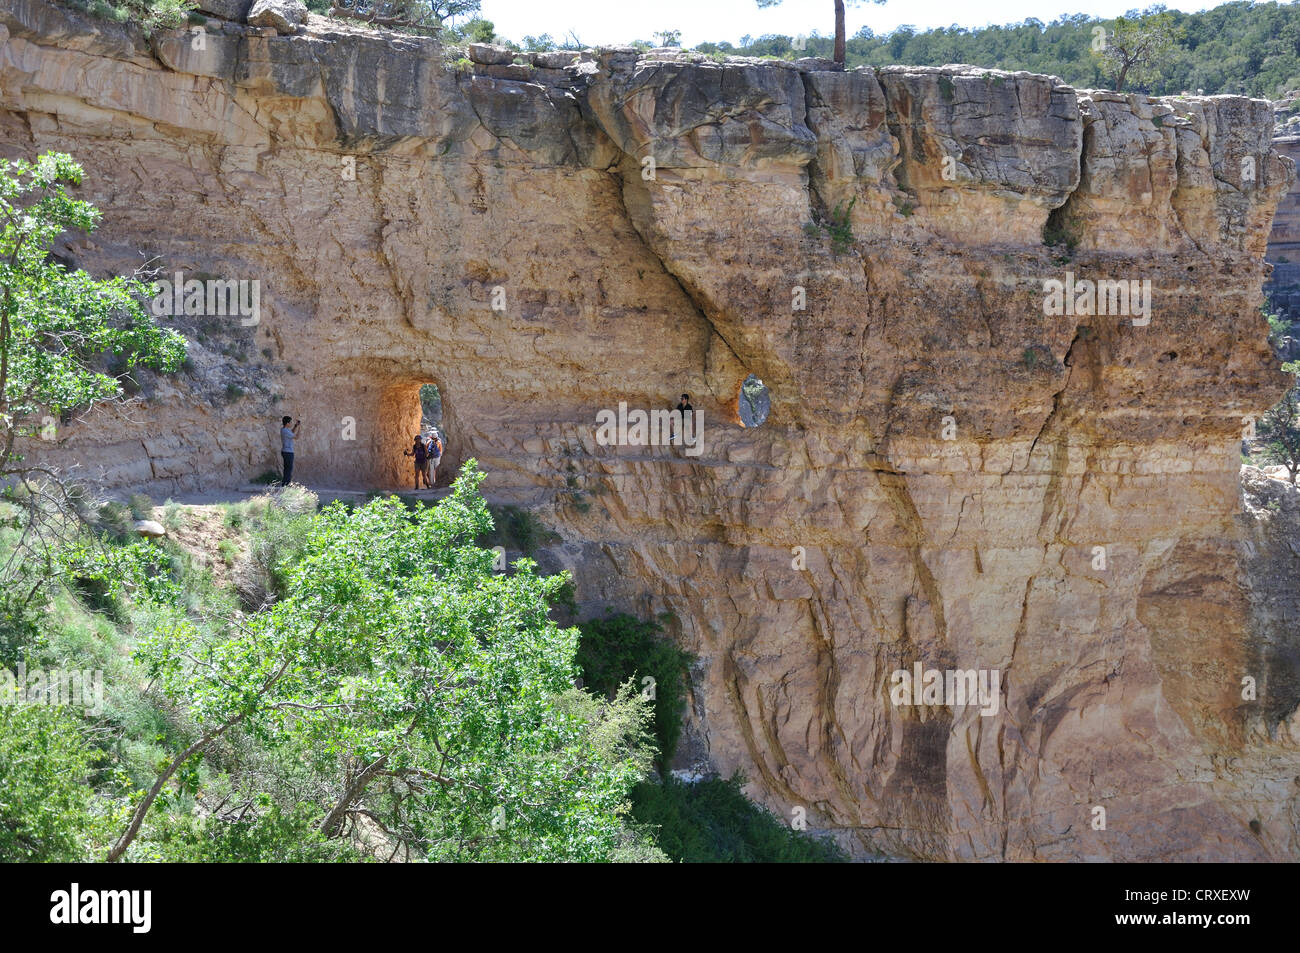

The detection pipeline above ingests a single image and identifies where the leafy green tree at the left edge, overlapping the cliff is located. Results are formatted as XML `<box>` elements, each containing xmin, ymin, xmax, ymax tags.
<box><xmin>0</xmin><ymin>152</ymin><xmax>186</xmax><ymax>501</ymax></box>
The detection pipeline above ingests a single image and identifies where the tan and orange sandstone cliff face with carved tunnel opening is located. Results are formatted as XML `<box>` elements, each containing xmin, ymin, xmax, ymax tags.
<box><xmin>0</xmin><ymin>0</ymin><xmax>1300</xmax><ymax>859</ymax></box>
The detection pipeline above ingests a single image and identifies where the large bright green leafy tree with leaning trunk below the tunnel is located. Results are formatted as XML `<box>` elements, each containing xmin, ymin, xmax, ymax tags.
<box><xmin>108</xmin><ymin>460</ymin><xmax>653</xmax><ymax>861</ymax></box>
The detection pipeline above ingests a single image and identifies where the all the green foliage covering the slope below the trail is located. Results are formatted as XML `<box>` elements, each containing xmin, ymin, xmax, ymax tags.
<box><xmin>0</xmin><ymin>473</ymin><xmax>666</xmax><ymax>862</ymax></box>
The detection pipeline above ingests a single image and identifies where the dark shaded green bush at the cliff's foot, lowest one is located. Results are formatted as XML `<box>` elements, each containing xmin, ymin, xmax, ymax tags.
<box><xmin>632</xmin><ymin>777</ymin><xmax>846</xmax><ymax>863</ymax></box>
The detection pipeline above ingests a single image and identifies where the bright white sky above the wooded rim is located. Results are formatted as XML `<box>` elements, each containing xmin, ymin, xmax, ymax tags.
<box><xmin>482</xmin><ymin>0</ymin><xmax>1222</xmax><ymax>46</ymax></box>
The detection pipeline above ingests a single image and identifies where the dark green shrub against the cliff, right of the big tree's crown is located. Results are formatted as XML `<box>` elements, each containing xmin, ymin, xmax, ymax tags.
<box><xmin>577</xmin><ymin>612</ymin><xmax>693</xmax><ymax>771</ymax></box>
